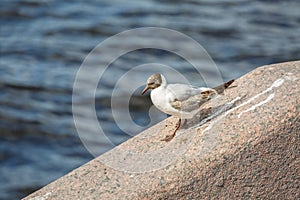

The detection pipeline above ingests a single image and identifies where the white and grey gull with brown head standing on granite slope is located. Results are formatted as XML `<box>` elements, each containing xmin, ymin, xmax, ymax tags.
<box><xmin>142</xmin><ymin>74</ymin><xmax>234</xmax><ymax>142</ymax></box>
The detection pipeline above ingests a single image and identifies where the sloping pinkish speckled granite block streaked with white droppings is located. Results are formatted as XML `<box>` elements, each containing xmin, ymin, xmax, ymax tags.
<box><xmin>25</xmin><ymin>61</ymin><xmax>300</xmax><ymax>200</ymax></box>
